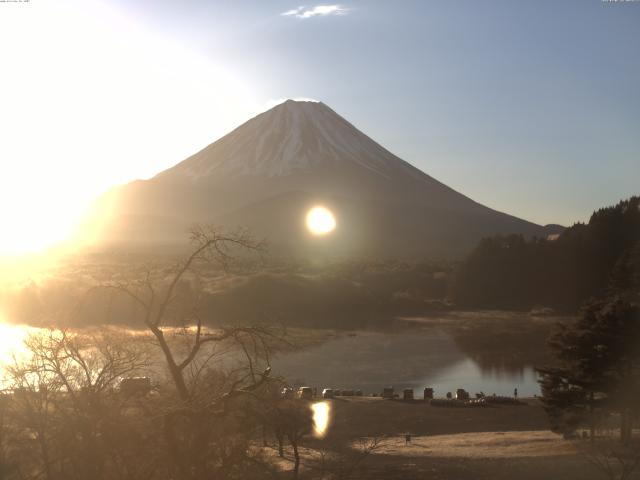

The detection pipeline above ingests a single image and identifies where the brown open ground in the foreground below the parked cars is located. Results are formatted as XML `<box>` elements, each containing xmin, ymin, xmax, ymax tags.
<box><xmin>262</xmin><ymin>398</ymin><xmax>605</xmax><ymax>480</ymax></box>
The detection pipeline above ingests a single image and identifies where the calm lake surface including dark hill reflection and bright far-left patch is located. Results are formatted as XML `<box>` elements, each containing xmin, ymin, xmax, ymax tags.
<box><xmin>0</xmin><ymin>314</ymin><xmax>544</xmax><ymax>398</ymax></box>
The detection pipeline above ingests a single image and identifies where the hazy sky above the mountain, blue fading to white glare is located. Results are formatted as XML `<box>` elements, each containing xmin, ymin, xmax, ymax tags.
<box><xmin>0</xmin><ymin>0</ymin><xmax>640</xmax><ymax>253</ymax></box>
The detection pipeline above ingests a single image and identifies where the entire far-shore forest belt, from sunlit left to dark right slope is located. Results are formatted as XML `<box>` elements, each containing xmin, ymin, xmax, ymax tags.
<box><xmin>0</xmin><ymin>197</ymin><xmax>640</xmax><ymax>328</ymax></box>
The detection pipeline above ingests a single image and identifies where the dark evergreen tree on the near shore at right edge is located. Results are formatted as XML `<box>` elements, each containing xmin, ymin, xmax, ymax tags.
<box><xmin>538</xmin><ymin>297</ymin><xmax>640</xmax><ymax>441</ymax></box>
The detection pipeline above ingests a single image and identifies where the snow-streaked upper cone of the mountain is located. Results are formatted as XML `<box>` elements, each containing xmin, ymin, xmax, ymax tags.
<box><xmin>160</xmin><ymin>100</ymin><xmax>408</xmax><ymax>182</ymax></box>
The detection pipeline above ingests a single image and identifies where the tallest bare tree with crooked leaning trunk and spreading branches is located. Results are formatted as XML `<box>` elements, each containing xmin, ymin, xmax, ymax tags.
<box><xmin>95</xmin><ymin>227</ymin><xmax>284</xmax><ymax>479</ymax></box>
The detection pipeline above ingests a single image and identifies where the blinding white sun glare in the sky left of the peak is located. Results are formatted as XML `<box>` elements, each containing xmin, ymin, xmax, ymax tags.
<box><xmin>0</xmin><ymin>0</ymin><xmax>261</xmax><ymax>257</ymax></box>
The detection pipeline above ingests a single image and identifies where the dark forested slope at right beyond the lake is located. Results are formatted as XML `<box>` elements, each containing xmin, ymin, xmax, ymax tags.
<box><xmin>453</xmin><ymin>197</ymin><xmax>640</xmax><ymax>311</ymax></box>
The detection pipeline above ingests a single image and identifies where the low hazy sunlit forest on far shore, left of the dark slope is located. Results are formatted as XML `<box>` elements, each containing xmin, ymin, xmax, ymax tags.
<box><xmin>0</xmin><ymin>260</ymin><xmax>451</xmax><ymax>328</ymax></box>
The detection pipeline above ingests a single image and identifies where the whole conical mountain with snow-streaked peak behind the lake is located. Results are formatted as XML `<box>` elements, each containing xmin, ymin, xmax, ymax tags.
<box><xmin>95</xmin><ymin>100</ymin><xmax>549</xmax><ymax>258</ymax></box>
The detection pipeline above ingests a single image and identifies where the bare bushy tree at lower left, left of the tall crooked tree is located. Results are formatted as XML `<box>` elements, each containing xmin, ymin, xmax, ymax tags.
<box><xmin>7</xmin><ymin>329</ymin><xmax>148</xmax><ymax>480</ymax></box>
